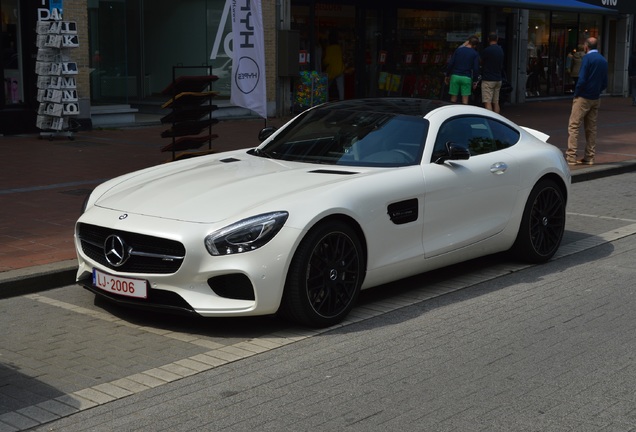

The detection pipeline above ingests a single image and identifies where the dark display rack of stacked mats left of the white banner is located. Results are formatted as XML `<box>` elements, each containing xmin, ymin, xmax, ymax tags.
<box><xmin>161</xmin><ymin>66</ymin><xmax>218</xmax><ymax>160</ymax></box>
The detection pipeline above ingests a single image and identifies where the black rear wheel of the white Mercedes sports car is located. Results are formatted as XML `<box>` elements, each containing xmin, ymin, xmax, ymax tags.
<box><xmin>512</xmin><ymin>179</ymin><xmax>566</xmax><ymax>263</ymax></box>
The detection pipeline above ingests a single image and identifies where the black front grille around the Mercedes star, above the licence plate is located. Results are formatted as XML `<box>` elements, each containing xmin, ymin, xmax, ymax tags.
<box><xmin>78</xmin><ymin>223</ymin><xmax>185</xmax><ymax>274</ymax></box>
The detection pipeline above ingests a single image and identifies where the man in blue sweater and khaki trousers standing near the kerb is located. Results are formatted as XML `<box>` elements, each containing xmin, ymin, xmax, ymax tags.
<box><xmin>565</xmin><ymin>37</ymin><xmax>608</xmax><ymax>165</ymax></box>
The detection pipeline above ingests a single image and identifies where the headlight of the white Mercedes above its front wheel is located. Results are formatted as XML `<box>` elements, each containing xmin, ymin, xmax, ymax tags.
<box><xmin>205</xmin><ymin>212</ymin><xmax>289</xmax><ymax>255</ymax></box>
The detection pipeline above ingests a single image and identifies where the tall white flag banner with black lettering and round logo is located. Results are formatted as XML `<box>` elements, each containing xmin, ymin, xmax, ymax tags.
<box><xmin>227</xmin><ymin>0</ymin><xmax>267</xmax><ymax>118</ymax></box>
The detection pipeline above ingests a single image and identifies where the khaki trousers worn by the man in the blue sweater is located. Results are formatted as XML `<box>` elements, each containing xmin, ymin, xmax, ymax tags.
<box><xmin>565</xmin><ymin>97</ymin><xmax>601</xmax><ymax>162</ymax></box>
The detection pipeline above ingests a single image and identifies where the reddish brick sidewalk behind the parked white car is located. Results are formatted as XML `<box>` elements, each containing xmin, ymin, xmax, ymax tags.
<box><xmin>0</xmin><ymin>97</ymin><xmax>636</xmax><ymax>298</ymax></box>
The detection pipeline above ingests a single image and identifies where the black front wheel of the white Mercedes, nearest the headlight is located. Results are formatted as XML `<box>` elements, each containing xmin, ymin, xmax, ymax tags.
<box><xmin>280</xmin><ymin>221</ymin><xmax>365</xmax><ymax>327</ymax></box>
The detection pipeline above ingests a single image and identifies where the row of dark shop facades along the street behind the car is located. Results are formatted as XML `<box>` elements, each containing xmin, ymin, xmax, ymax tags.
<box><xmin>0</xmin><ymin>0</ymin><xmax>636</xmax><ymax>134</ymax></box>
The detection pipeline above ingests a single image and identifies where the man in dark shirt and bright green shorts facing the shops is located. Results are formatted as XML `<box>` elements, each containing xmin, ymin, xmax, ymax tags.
<box><xmin>445</xmin><ymin>36</ymin><xmax>479</xmax><ymax>105</ymax></box>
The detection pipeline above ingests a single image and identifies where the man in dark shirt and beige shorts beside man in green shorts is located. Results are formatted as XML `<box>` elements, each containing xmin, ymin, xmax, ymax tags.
<box><xmin>481</xmin><ymin>33</ymin><xmax>504</xmax><ymax>113</ymax></box>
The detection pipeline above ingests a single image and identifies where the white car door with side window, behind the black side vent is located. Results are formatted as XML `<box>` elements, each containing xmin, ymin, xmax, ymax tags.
<box><xmin>423</xmin><ymin>116</ymin><xmax>519</xmax><ymax>258</ymax></box>
